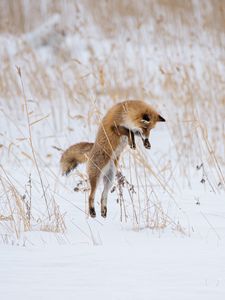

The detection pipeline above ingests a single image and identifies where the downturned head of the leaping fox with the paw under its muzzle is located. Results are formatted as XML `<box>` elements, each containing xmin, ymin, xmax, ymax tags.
<box><xmin>121</xmin><ymin>100</ymin><xmax>166</xmax><ymax>148</ymax></box>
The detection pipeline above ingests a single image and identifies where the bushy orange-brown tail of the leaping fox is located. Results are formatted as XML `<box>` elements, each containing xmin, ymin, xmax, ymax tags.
<box><xmin>60</xmin><ymin>142</ymin><xmax>94</xmax><ymax>175</ymax></box>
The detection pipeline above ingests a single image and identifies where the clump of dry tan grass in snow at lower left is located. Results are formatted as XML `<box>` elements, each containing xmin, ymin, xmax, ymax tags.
<box><xmin>0</xmin><ymin>166</ymin><xmax>66</xmax><ymax>240</ymax></box>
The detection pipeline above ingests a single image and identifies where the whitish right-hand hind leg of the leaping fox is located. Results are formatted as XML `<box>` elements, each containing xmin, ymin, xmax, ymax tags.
<box><xmin>101</xmin><ymin>161</ymin><xmax>116</xmax><ymax>218</ymax></box>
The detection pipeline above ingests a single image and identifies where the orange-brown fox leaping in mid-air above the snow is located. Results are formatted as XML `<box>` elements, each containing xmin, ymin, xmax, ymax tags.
<box><xmin>60</xmin><ymin>100</ymin><xmax>166</xmax><ymax>218</ymax></box>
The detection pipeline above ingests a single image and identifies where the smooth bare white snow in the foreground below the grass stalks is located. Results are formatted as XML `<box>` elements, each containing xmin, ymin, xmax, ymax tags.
<box><xmin>0</xmin><ymin>233</ymin><xmax>225</xmax><ymax>300</ymax></box>
